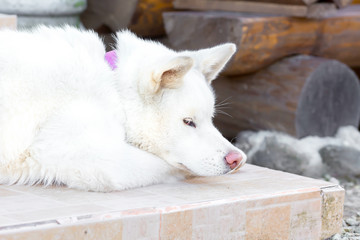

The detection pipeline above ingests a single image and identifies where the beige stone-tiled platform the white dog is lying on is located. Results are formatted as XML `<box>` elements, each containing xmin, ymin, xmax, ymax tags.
<box><xmin>0</xmin><ymin>164</ymin><xmax>344</xmax><ymax>240</ymax></box>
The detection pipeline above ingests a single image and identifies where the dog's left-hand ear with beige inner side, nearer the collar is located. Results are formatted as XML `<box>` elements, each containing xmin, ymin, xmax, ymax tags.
<box><xmin>151</xmin><ymin>56</ymin><xmax>194</xmax><ymax>93</ymax></box>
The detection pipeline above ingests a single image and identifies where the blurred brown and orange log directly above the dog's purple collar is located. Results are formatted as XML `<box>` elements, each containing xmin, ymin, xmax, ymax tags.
<box><xmin>81</xmin><ymin>0</ymin><xmax>173</xmax><ymax>37</ymax></box>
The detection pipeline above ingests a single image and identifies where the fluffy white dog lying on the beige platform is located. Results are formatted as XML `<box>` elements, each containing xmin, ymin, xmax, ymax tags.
<box><xmin>0</xmin><ymin>27</ymin><xmax>246</xmax><ymax>191</ymax></box>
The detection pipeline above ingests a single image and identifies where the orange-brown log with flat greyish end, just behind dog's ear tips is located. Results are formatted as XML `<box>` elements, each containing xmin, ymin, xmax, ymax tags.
<box><xmin>164</xmin><ymin>5</ymin><xmax>360</xmax><ymax>76</ymax></box>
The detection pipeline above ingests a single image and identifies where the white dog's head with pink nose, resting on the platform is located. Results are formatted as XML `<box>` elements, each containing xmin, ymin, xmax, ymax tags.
<box><xmin>115</xmin><ymin>32</ymin><xmax>246</xmax><ymax>176</ymax></box>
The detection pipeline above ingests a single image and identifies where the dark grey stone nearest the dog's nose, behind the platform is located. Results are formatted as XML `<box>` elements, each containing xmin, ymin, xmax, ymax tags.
<box><xmin>251</xmin><ymin>137</ymin><xmax>309</xmax><ymax>174</ymax></box>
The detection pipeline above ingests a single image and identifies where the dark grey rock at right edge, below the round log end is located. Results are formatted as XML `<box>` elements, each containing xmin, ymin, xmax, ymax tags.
<box><xmin>319</xmin><ymin>145</ymin><xmax>360</xmax><ymax>179</ymax></box>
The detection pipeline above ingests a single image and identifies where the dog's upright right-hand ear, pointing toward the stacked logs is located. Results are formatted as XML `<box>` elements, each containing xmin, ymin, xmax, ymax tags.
<box><xmin>194</xmin><ymin>43</ymin><xmax>236</xmax><ymax>83</ymax></box>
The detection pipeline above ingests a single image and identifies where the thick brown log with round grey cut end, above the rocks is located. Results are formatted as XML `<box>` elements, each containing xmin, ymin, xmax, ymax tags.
<box><xmin>213</xmin><ymin>55</ymin><xmax>360</xmax><ymax>138</ymax></box>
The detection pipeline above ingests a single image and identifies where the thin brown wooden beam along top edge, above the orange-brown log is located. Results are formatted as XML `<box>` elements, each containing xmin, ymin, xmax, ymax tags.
<box><xmin>174</xmin><ymin>0</ymin><xmax>336</xmax><ymax>18</ymax></box>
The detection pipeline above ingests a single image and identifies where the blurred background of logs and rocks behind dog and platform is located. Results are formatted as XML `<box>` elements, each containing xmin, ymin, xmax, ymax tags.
<box><xmin>0</xmin><ymin>0</ymin><xmax>360</xmax><ymax>236</ymax></box>
